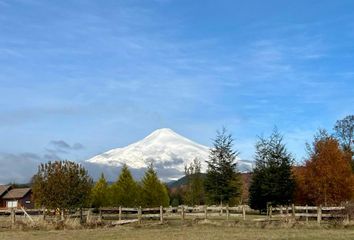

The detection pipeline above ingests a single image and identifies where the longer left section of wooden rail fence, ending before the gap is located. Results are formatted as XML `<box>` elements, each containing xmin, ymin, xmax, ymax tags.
<box><xmin>0</xmin><ymin>205</ymin><xmax>253</xmax><ymax>224</ymax></box>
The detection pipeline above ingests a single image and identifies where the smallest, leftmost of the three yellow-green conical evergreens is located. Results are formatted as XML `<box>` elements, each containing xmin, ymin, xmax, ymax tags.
<box><xmin>91</xmin><ymin>173</ymin><xmax>110</xmax><ymax>208</ymax></box>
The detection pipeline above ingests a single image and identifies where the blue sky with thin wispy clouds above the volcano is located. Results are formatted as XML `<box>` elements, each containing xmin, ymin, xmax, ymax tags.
<box><xmin>0</xmin><ymin>0</ymin><xmax>354</xmax><ymax>180</ymax></box>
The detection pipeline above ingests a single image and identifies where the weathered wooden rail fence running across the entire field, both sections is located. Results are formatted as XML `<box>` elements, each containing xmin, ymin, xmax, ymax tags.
<box><xmin>0</xmin><ymin>205</ymin><xmax>349</xmax><ymax>225</ymax></box>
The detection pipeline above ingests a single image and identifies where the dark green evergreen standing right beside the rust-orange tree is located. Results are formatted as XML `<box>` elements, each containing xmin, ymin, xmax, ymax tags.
<box><xmin>249</xmin><ymin>129</ymin><xmax>295</xmax><ymax>211</ymax></box>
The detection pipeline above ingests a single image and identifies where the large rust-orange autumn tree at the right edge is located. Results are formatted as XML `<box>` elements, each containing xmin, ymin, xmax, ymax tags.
<box><xmin>294</xmin><ymin>130</ymin><xmax>354</xmax><ymax>205</ymax></box>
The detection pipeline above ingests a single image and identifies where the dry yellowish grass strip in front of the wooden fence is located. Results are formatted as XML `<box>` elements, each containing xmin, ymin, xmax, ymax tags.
<box><xmin>0</xmin><ymin>225</ymin><xmax>354</xmax><ymax>240</ymax></box>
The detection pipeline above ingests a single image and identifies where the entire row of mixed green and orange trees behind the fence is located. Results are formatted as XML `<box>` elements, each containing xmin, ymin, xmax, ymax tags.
<box><xmin>32</xmin><ymin>115</ymin><xmax>354</xmax><ymax>211</ymax></box>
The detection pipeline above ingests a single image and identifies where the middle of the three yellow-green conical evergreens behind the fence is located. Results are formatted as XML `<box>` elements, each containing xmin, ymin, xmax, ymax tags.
<box><xmin>111</xmin><ymin>164</ymin><xmax>140</xmax><ymax>207</ymax></box>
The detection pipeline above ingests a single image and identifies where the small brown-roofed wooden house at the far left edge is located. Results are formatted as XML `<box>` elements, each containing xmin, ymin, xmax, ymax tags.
<box><xmin>0</xmin><ymin>186</ymin><xmax>34</xmax><ymax>208</ymax></box>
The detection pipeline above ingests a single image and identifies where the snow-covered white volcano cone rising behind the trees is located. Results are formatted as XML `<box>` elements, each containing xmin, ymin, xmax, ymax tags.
<box><xmin>86</xmin><ymin>128</ymin><xmax>253</xmax><ymax>178</ymax></box>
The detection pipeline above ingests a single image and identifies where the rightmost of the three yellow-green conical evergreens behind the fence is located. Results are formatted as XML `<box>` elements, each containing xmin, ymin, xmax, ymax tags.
<box><xmin>141</xmin><ymin>164</ymin><xmax>170</xmax><ymax>207</ymax></box>
